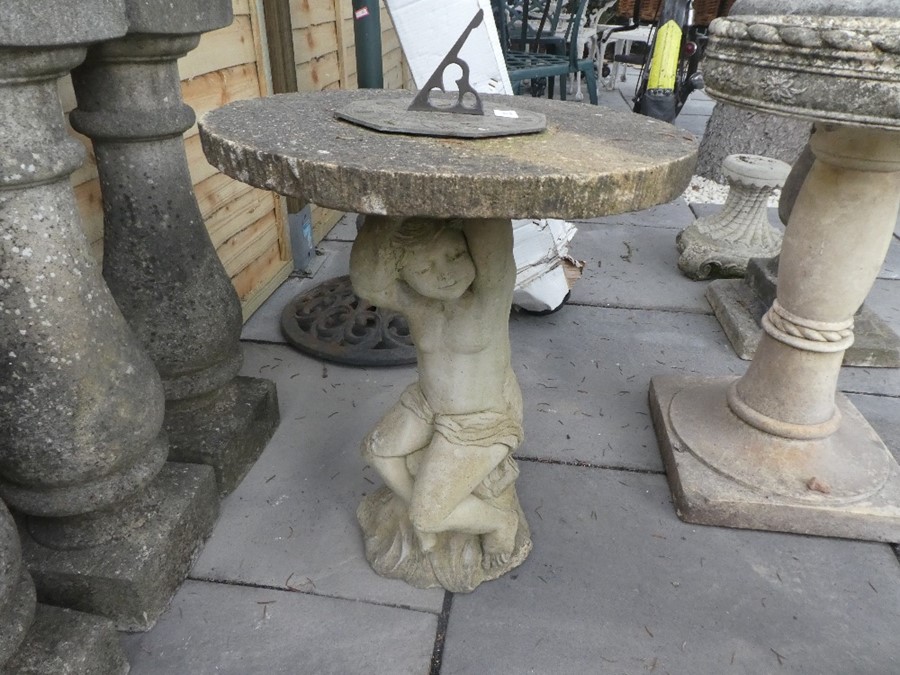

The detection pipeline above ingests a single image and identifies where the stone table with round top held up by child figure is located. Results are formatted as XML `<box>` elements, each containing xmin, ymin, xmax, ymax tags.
<box><xmin>200</xmin><ymin>90</ymin><xmax>696</xmax><ymax>592</ymax></box>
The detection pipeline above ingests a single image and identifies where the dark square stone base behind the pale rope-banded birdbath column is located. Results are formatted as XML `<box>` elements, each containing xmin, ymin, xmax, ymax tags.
<box><xmin>706</xmin><ymin>279</ymin><xmax>900</xmax><ymax>368</ymax></box>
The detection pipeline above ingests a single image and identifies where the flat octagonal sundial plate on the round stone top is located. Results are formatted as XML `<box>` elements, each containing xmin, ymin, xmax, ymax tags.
<box><xmin>335</xmin><ymin>98</ymin><xmax>547</xmax><ymax>138</ymax></box>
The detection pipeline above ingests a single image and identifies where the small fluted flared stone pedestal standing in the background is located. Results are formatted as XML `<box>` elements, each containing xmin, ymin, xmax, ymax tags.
<box><xmin>675</xmin><ymin>155</ymin><xmax>791</xmax><ymax>281</ymax></box>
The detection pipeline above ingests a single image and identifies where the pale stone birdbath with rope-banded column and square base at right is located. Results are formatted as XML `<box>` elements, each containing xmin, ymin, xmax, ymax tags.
<box><xmin>650</xmin><ymin>0</ymin><xmax>900</xmax><ymax>542</ymax></box>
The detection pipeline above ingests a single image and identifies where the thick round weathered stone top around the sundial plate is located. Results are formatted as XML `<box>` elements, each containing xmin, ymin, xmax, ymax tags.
<box><xmin>200</xmin><ymin>89</ymin><xmax>697</xmax><ymax>218</ymax></box>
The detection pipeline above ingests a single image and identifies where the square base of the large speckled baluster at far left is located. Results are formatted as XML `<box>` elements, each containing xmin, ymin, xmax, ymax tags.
<box><xmin>20</xmin><ymin>462</ymin><xmax>219</xmax><ymax>631</ymax></box>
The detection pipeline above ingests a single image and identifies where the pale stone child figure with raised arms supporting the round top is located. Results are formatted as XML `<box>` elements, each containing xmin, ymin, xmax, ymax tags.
<box><xmin>350</xmin><ymin>216</ymin><xmax>531</xmax><ymax>592</ymax></box>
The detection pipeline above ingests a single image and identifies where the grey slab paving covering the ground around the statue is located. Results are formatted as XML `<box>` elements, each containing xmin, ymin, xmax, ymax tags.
<box><xmin>123</xmin><ymin>75</ymin><xmax>900</xmax><ymax>675</ymax></box>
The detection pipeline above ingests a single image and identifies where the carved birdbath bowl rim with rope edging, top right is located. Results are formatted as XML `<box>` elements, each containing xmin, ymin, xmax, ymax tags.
<box><xmin>704</xmin><ymin>16</ymin><xmax>900</xmax><ymax>130</ymax></box>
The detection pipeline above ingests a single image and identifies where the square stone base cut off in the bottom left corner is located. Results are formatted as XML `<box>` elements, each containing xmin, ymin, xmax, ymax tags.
<box><xmin>2</xmin><ymin>604</ymin><xmax>129</xmax><ymax>675</ymax></box>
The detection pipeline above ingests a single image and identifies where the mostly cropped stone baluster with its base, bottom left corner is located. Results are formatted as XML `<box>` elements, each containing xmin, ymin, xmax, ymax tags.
<box><xmin>0</xmin><ymin>502</ymin><xmax>129</xmax><ymax>675</ymax></box>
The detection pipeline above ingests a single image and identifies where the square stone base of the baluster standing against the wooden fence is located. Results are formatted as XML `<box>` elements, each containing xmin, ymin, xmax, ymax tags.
<box><xmin>165</xmin><ymin>377</ymin><xmax>279</xmax><ymax>497</ymax></box>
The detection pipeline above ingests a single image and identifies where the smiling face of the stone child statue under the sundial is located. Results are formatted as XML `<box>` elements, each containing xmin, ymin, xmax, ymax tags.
<box><xmin>400</xmin><ymin>228</ymin><xmax>475</xmax><ymax>300</ymax></box>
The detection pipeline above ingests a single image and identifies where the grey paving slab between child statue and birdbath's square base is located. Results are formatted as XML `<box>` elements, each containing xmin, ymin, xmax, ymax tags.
<box><xmin>510</xmin><ymin>306</ymin><xmax>748</xmax><ymax>471</ymax></box>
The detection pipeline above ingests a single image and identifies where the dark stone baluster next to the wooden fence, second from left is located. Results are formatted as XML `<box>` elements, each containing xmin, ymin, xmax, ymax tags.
<box><xmin>70</xmin><ymin>0</ymin><xmax>278</xmax><ymax>493</ymax></box>
